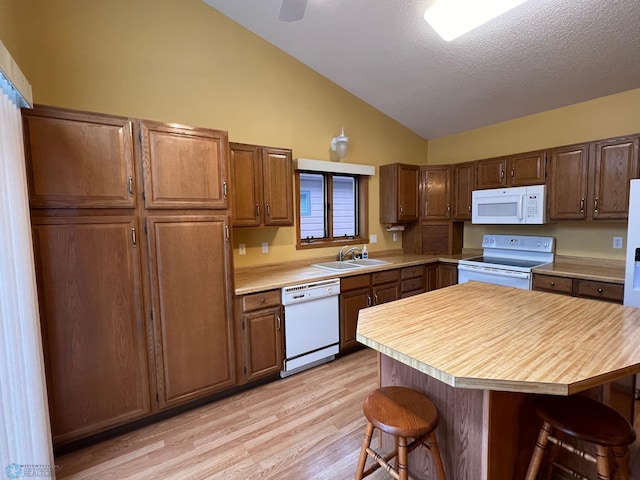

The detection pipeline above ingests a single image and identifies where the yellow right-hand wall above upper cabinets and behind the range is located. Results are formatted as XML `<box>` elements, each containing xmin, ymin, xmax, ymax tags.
<box><xmin>428</xmin><ymin>89</ymin><xmax>640</xmax><ymax>260</ymax></box>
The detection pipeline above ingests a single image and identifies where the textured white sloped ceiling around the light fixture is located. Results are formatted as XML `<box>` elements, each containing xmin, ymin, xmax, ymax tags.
<box><xmin>204</xmin><ymin>0</ymin><xmax>640</xmax><ymax>139</ymax></box>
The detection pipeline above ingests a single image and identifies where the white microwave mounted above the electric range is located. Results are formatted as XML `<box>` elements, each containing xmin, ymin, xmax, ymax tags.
<box><xmin>471</xmin><ymin>185</ymin><xmax>547</xmax><ymax>225</ymax></box>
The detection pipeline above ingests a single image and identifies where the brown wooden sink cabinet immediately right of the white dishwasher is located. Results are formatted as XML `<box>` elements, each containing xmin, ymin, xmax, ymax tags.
<box><xmin>340</xmin><ymin>269</ymin><xmax>400</xmax><ymax>353</ymax></box>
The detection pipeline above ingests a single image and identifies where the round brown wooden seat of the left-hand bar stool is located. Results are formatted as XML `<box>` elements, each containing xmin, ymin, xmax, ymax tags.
<box><xmin>362</xmin><ymin>387</ymin><xmax>440</xmax><ymax>437</ymax></box>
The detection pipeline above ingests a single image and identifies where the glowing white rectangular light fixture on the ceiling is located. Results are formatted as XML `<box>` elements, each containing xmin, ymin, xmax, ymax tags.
<box><xmin>424</xmin><ymin>0</ymin><xmax>526</xmax><ymax>41</ymax></box>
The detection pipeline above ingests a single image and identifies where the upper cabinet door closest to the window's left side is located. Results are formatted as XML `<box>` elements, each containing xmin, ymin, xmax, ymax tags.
<box><xmin>262</xmin><ymin>147</ymin><xmax>293</xmax><ymax>225</ymax></box>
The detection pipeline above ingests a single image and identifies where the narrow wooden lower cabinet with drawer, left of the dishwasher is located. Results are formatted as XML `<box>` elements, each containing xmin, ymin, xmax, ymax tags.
<box><xmin>236</xmin><ymin>290</ymin><xmax>284</xmax><ymax>383</ymax></box>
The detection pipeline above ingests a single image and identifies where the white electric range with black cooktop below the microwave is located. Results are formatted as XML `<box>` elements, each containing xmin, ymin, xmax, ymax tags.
<box><xmin>458</xmin><ymin>235</ymin><xmax>555</xmax><ymax>290</ymax></box>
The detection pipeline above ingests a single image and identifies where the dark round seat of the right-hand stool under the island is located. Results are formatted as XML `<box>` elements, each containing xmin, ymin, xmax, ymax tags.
<box><xmin>534</xmin><ymin>395</ymin><xmax>636</xmax><ymax>447</ymax></box>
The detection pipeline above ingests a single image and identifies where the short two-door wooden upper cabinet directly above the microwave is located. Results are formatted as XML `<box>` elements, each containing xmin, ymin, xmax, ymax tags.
<box><xmin>478</xmin><ymin>150</ymin><xmax>547</xmax><ymax>190</ymax></box>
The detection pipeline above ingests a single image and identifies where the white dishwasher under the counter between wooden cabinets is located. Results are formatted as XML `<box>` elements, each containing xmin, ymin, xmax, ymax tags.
<box><xmin>280</xmin><ymin>278</ymin><xmax>340</xmax><ymax>377</ymax></box>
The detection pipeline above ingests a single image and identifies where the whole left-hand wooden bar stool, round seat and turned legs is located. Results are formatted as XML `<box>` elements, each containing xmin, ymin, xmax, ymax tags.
<box><xmin>356</xmin><ymin>387</ymin><xmax>446</xmax><ymax>480</ymax></box>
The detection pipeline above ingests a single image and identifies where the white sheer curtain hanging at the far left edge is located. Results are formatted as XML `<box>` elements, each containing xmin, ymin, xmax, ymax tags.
<box><xmin>0</xmin><ymin>72</ymin><xmax>55</xmax><ymax>478</ymax></box>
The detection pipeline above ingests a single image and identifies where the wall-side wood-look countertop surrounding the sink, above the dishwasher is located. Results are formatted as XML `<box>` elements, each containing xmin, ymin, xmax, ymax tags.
<box><xmin>234</xmin><ymin>251</ymin><xmax>478</xmax><ymax>295</ymax></box>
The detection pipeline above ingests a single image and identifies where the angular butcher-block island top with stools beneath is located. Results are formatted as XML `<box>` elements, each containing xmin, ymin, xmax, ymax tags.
<box><xmin>356</xmin><ymin>282</ymin><xmax>640</xmax><ymax>395</ymax></box>
